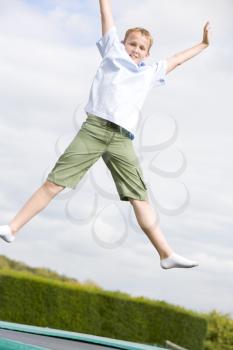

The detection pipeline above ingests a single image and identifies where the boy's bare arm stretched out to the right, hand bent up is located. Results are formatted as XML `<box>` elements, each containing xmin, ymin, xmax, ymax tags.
<box><xmin>166</xmin><ymin>22</ymin><xmax>210</xmax><ymax>74</ymax></box>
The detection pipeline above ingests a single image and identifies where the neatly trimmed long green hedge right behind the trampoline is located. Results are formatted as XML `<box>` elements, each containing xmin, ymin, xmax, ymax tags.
<box><xmin>0</xmin><ymin>270</ymin><xmax>207</xmax><ymax>350</ymax></box>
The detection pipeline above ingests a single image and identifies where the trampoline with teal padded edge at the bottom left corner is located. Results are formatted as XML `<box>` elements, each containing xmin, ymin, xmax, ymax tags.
<box><xmin>0</xmin><ymin>321</ymin><xmax>164</xmax><ymax>350</ymax></box>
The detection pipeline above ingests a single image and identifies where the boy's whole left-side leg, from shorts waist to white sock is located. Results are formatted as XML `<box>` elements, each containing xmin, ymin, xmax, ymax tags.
<box><xmin>0</xmin><ymin>118</ymin><xmax>109</xmax><ymax>242</ymax></box>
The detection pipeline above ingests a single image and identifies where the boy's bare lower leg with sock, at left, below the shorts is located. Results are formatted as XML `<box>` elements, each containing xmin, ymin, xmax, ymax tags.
<box><xmin>0</xmin><ymin>181</ymin><xmax>64</xmax><ymax>242</ymax></box>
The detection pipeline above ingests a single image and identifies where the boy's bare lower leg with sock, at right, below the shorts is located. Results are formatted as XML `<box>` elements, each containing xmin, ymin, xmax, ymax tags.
<box><xmin>129</xmin><ymin>198</ymin><xmax>198</xmax><ymax>269</ymax></box>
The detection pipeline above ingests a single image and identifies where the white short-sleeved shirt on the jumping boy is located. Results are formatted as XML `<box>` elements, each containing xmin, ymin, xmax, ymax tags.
<box><xmin>85</xmin><ymin>26</ymin><xmax>167</xmax><ymax>134</ymax></box>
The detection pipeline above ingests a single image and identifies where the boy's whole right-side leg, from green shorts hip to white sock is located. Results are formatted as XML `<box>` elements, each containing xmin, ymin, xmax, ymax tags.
<box><xmin>103</xmin><ymin>133</ymin><xmax>198</xmax><ymax>269</ymax></box>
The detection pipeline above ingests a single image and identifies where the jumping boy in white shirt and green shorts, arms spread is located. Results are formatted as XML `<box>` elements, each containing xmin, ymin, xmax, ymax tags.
<box><xmin>0</xmin><ymin>0</ymin><xmax>209</xmax><ymax>269</ymax></box>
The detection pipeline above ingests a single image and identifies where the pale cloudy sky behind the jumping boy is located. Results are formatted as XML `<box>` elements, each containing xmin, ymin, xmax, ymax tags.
<box><xmin>0</xmin><ymin>0</ymin><xmax>233</xmax><ymax>317</ymax></box>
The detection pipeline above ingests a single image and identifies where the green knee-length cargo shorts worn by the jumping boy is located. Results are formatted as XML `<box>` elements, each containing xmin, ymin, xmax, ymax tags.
<box><xmin>47</xmin><ymin>115</ymin><xmax>148</xmax><ymax>201</ymax></box>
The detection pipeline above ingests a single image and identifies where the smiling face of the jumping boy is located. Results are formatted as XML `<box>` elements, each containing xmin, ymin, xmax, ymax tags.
<box><xmin>124</xmin><ymin>32</ymin><xmax>150</xmax><ymax>64</ymax></box>
